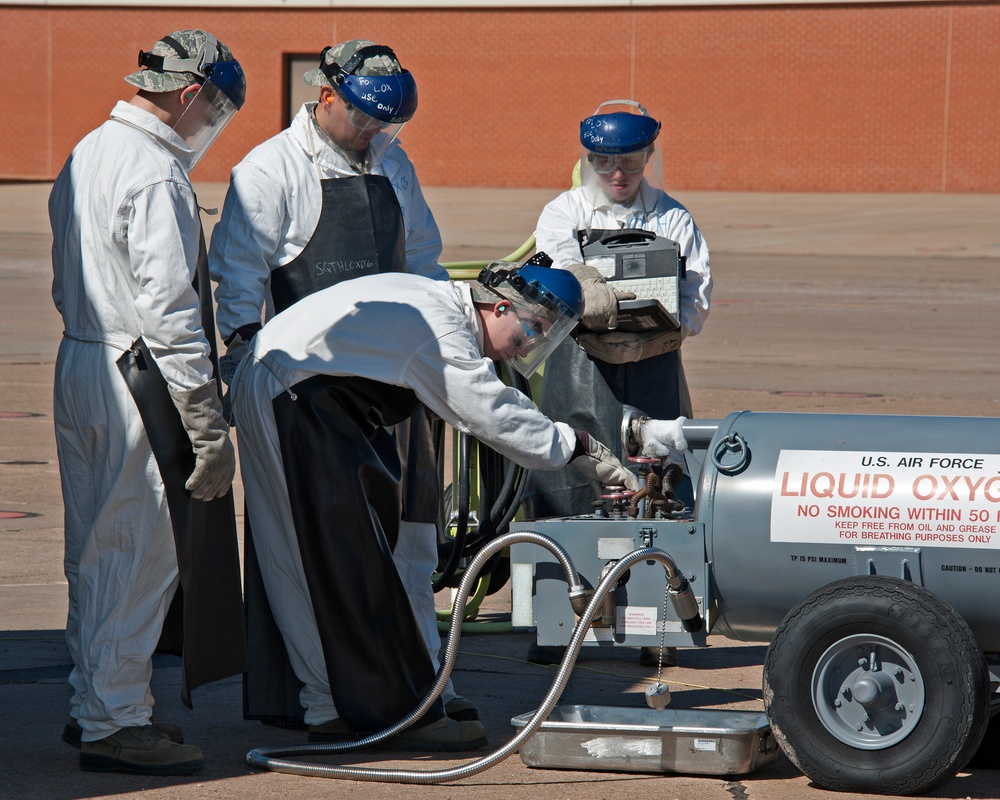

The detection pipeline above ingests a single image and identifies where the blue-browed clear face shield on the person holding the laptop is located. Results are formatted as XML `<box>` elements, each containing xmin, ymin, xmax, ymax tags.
<box><xmin>580</xmin><ymin>100</ymin><xmax>663</xmax><ymax>207</ymax></box>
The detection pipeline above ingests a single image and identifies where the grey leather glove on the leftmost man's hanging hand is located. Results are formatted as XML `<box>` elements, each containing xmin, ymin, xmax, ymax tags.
<box><xmin>170</xmin><ymin>380</ymin><xmax>236</xmax><ymax>501</ymax></box>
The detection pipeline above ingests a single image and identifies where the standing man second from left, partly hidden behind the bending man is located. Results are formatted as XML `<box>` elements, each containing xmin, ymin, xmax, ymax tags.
<box><xmin>209</xmin><ymin>39</ymin><xmax>478</xmax><ymax>721</ymax></box>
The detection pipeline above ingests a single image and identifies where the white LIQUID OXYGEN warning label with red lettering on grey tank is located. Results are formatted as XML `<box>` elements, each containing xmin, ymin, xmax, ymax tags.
<box><xmin>771</xmin><ymin>450</ymin><xmax>1000</xmax><ymax>550</ymax></box>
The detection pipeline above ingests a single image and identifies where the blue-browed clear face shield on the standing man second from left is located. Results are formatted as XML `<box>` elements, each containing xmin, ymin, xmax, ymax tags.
<box><xmin>320</xmin><ymin>45</ymin><xmax>417</xmax><ymax>171</ymax></box>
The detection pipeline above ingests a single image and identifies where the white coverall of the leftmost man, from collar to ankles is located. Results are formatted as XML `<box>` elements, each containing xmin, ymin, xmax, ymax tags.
<box><xmin>49</xmin><ymin>102</ymin><xmax>213</xmax><ymax>741</ymax></box>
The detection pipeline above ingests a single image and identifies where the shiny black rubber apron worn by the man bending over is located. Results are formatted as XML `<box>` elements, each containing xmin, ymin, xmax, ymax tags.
<box><xmin>273</xmin><ymin>376</ymin><xmax>444</xmax><ymax>733</ymax></box>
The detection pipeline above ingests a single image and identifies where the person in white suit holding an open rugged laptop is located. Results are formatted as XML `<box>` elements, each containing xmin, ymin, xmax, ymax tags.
<box><xmin>527</xmin><ymin>100</ymin><xmax>712</xmax><ymax>519</ymax></box>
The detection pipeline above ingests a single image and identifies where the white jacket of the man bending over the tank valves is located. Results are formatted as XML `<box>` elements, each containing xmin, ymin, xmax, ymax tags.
<box><xmin>232</xmin><ymin>273</ymin><xmax>576</xmax><ymax>469</ymax></box>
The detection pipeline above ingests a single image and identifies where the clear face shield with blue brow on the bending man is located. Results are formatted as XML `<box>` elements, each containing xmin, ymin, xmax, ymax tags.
<box><xmin>479</xmin><ymin>254</ymin><xmax>583</xmax><ymax>378</ymax></box>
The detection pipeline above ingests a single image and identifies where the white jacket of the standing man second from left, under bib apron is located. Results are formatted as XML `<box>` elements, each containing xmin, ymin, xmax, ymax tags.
<box><xmin>209</xmin><ymin>103</ymin><xmax>448</xmax><ymax>339</ymax></box>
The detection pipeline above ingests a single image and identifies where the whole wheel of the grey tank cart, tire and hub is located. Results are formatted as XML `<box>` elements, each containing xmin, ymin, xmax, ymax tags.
<box><xmin>764</xmin><ymin>576</ymin><xmax>990</xmax><ymax>795</ymax></box>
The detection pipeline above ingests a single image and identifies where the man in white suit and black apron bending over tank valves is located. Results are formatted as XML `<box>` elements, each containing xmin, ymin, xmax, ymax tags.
<box><xmin>231</xmin><ymin>256</ymin><xmax>638</xmax><ymax>750</ymax></box>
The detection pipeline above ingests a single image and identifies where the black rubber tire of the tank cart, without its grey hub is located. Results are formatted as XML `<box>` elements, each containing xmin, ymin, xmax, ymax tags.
<box><xmin>764</xmin><ymin>576</ymin><xmax>990</xmax><ymax>795</ymax></box>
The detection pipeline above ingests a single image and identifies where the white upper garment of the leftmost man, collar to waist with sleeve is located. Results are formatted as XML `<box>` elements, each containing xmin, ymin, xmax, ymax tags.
<box><xmin>49</xmin><ymin>102</ymin><xmax>213</xmax><ymax>391</ymax></box>
